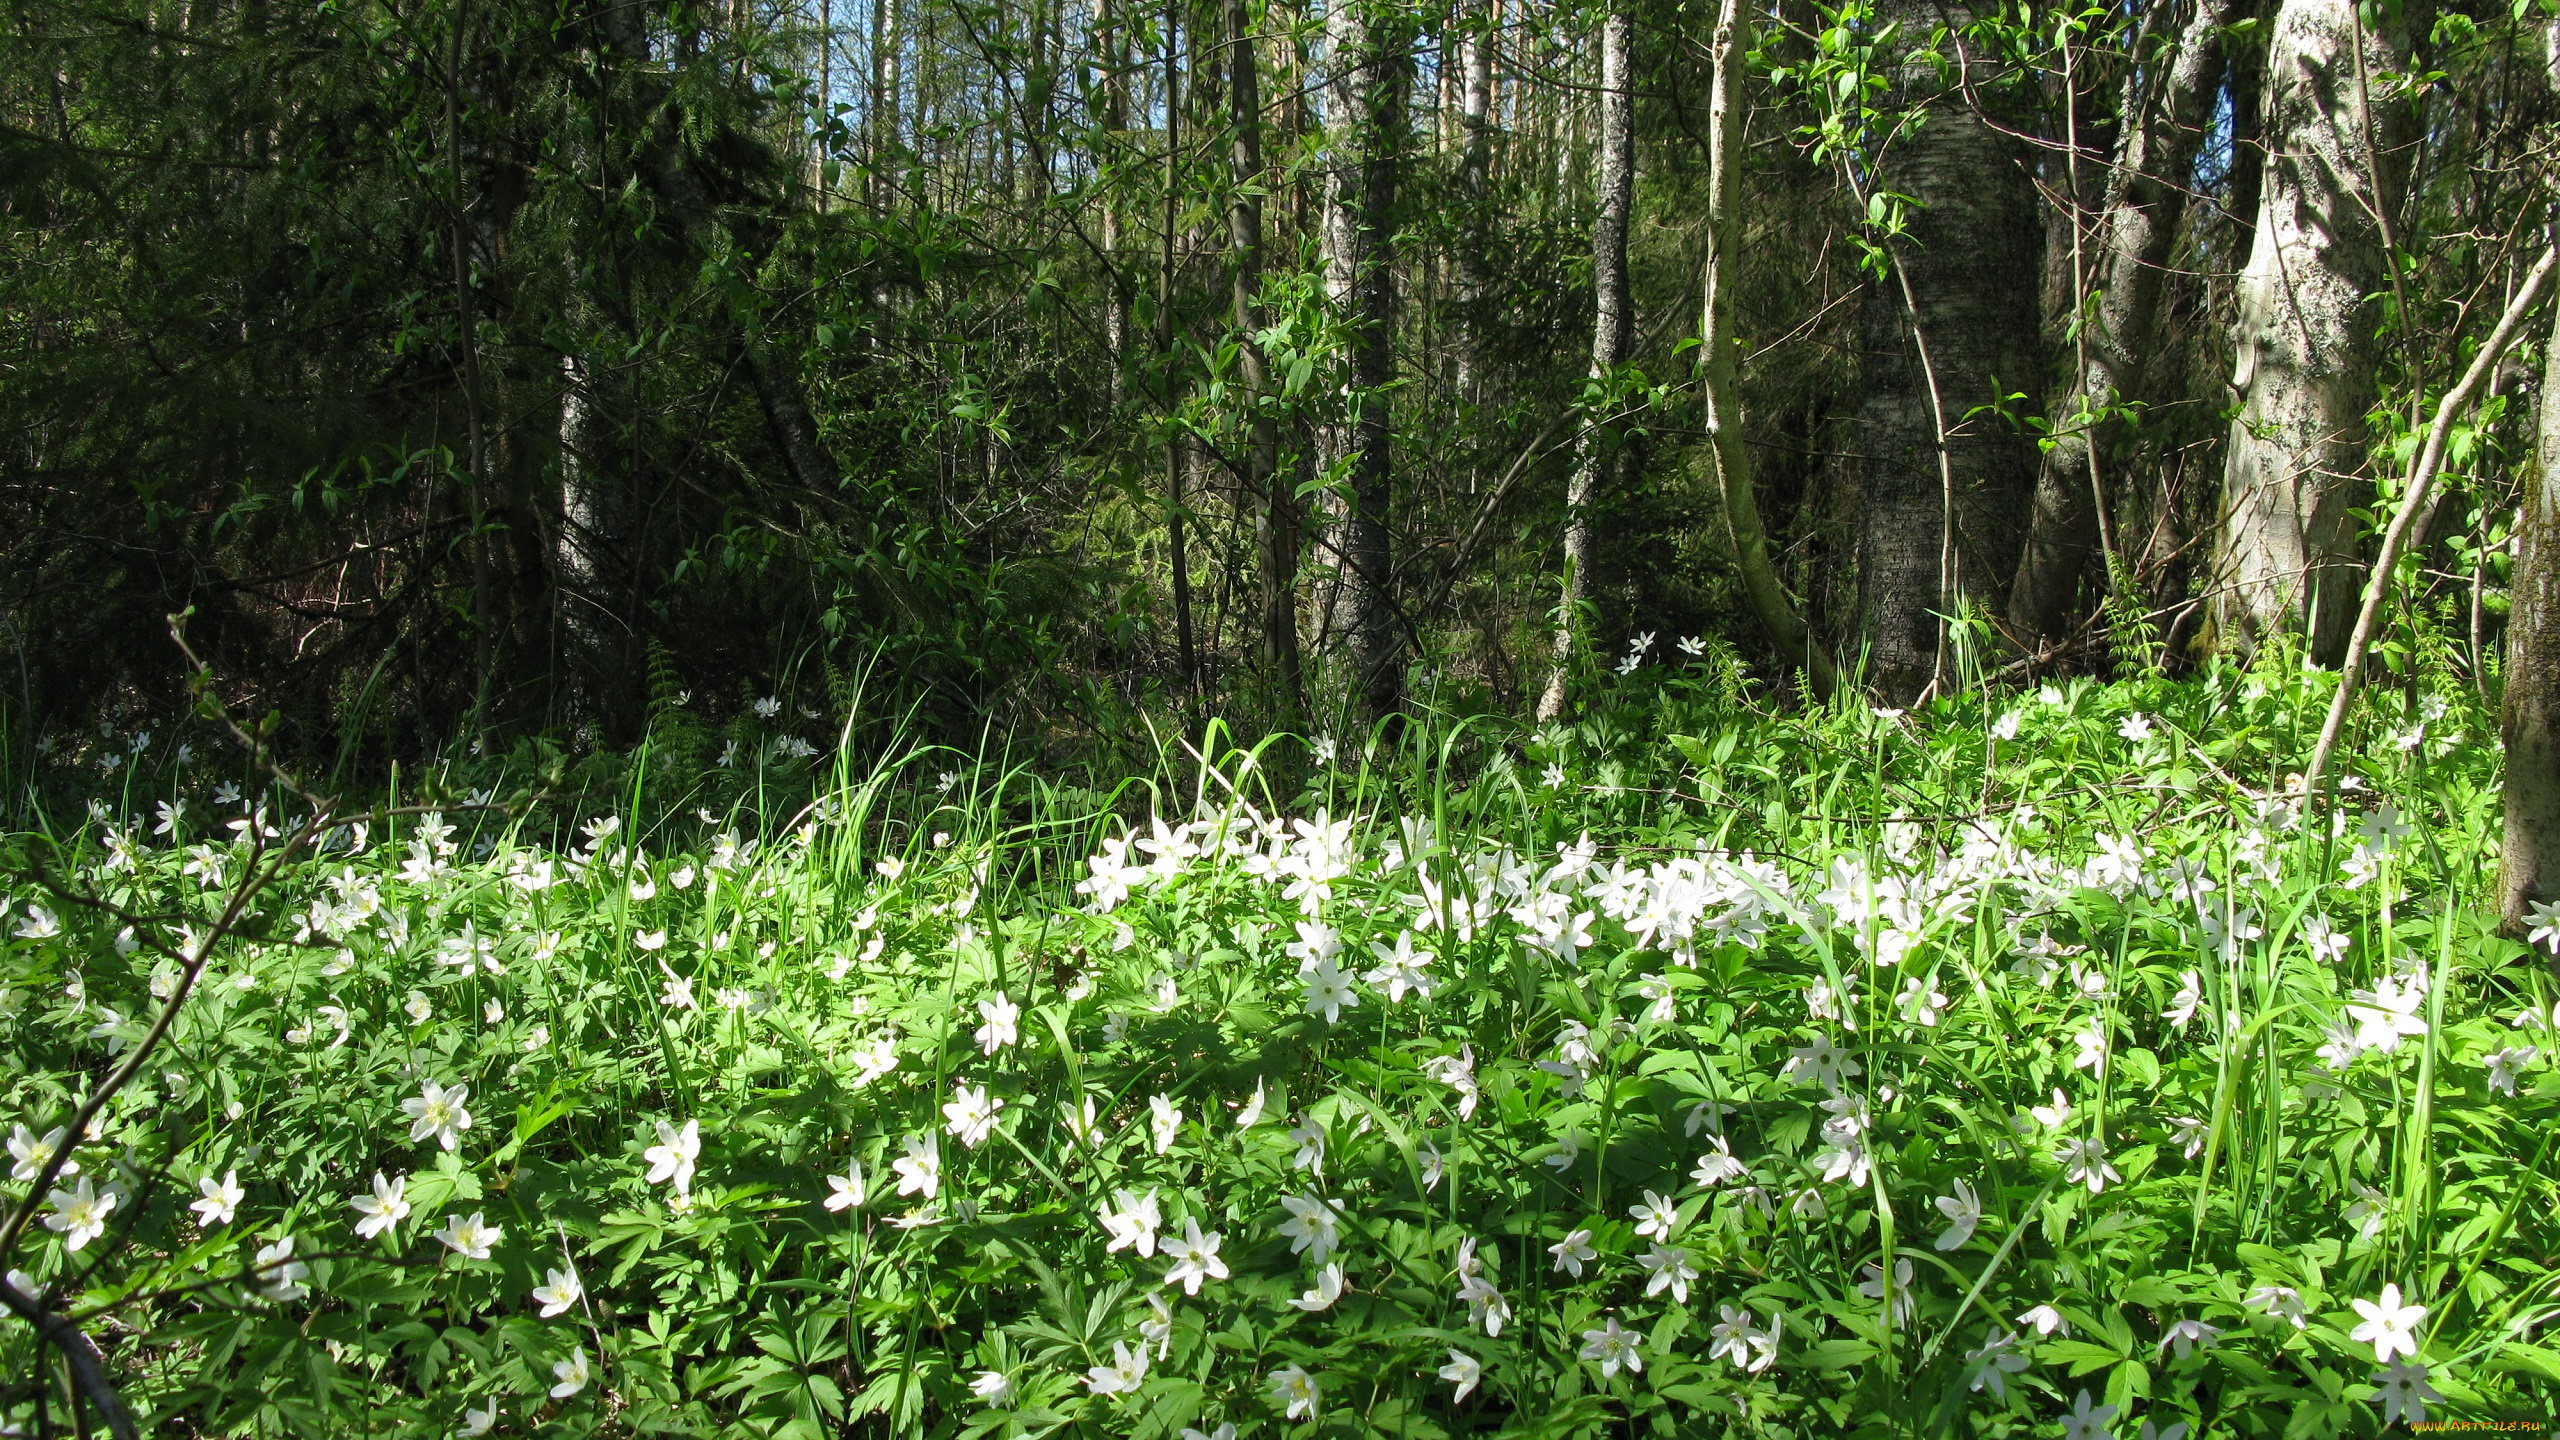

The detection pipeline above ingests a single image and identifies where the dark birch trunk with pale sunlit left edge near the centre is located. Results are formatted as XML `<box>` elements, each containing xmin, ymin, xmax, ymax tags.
<box><xmin>1324</xmin><ymin>0</ymin><xmax>1413</xmax><ymax>723</ymax></box>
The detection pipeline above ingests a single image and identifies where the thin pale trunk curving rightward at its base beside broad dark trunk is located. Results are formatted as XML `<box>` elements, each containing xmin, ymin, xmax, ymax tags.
<box><xmin>1700</xmin><ymin>0</ymin><xmax>1838</xmax><ymax>700</ymax></box>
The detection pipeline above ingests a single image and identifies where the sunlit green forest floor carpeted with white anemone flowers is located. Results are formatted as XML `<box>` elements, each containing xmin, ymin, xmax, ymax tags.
<box><xmin>0</xmin><ymin>664</ymin><xmax>2560</xmax><ymax>1440</ymax></box>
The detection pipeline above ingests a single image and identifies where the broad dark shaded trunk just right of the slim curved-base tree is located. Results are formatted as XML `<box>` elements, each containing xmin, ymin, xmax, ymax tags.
<box><xmin>1859</xmin><ymin>5</ymin><xmax>2043</xmax><ymax>705</ymax></box>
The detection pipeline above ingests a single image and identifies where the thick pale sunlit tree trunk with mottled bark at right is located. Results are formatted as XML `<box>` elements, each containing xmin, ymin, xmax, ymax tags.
<box><xmin>2214</xmin><ymin>0</ymin><xmax>2409</xmax><ymax>664</ymax></box>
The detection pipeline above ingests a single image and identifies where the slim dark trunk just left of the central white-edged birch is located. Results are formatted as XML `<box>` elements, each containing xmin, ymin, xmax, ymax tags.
<box><xmin>1226</xmin><ymin>0</ymin><xmax>1306</xmax><ymax>730</ymax></box>
